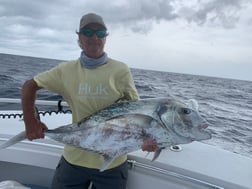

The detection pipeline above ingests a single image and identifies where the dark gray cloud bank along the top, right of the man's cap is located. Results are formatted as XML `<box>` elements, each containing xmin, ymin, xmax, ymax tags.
<box><xmin>87</xmin><ymin>0</ymin><xmax>249</xmax><ymax>33</ymax></box>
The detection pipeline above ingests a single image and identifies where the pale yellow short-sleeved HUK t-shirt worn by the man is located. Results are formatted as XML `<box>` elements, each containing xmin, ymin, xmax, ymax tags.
<box><xmin>34</xmin><ymin>58</ymin><xmax>139</xmax><ymax>169</ymax></box>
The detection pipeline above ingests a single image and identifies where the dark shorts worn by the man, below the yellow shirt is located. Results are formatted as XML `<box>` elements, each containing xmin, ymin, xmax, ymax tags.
<box><xmin>51</xmin><ymin>157</ymin><xmax>128</xmax><ymax>189</ymax></box>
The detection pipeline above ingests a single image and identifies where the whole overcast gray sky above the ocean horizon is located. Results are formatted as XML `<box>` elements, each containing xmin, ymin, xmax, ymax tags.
<box><xmin>0</xmin><ymin>0</ymin><xmax>252</xmax><ymax>81</ymax></box>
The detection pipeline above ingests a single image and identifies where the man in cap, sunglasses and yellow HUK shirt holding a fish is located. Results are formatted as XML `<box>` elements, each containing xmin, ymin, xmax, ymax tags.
<box><xmin>22</xmin><ymin>13</ymin><xmax>156</xmax><ymax>189</ymax></box>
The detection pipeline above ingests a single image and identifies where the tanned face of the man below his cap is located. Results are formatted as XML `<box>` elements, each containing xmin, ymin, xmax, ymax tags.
<box><xmin>79</xmin><ymin>24</ymin><xmax>107</xmax><ymax>58</ymax></box>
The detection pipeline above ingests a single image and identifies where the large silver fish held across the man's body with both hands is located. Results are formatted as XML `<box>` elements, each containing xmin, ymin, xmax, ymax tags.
<box><xmin>0</xmin><ymin>98</ymin><xmax>211</xmax><ymax>171</ymax></box>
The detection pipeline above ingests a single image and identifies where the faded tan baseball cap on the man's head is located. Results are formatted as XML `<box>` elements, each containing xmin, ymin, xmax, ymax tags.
<box><xmin>79</xmin><ymin>13</ymin><xmax>107</xmax><ymax>31</ymax></box>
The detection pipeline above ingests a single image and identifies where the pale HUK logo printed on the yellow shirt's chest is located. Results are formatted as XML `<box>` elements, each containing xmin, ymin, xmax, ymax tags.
<box><xmin>78</xmin><ymin>83</ymin><xmax>109</xmax><ymax>98</ymax></box>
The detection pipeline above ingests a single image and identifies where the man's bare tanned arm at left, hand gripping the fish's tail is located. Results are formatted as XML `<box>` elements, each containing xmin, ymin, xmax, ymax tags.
<box><xmin>22</xmin><ymin>79</ymin><xmax>47</xmax><ymax>140</ymax></box>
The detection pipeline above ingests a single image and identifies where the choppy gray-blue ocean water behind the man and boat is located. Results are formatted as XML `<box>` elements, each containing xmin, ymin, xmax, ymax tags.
<box><xmin>0</xmin><ymin>54</ymin><xmax>252</xmax><ymax>158</ymax></box>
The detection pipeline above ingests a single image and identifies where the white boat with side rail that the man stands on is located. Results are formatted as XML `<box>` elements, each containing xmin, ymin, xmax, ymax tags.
<box><xmin>0</xmin><ymin>98</ymin><xmax>252</xmax><ymax>189</ymax></box>
